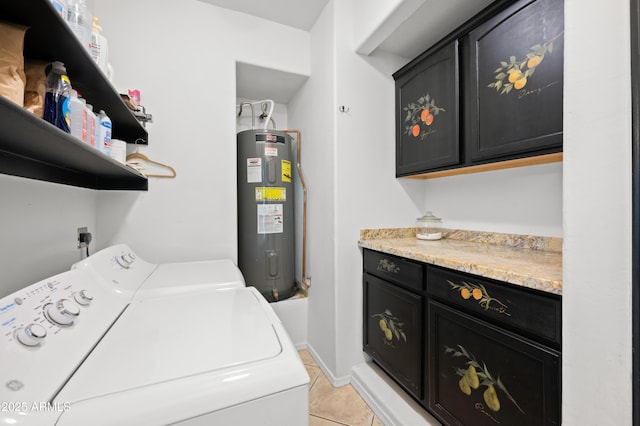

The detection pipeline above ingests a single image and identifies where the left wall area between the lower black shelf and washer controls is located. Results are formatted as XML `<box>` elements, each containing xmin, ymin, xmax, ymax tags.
<box><xmin>0</xmin><ymin>175</ymin><xmax>98</xmax><ymax>297</ymax></box>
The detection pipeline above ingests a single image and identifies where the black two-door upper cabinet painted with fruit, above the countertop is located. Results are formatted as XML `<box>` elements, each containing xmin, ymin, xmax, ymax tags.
<box><xmin>394</xmin><ymin>0</ymin><xmax>564</xmax><ymax>177</ymax></box>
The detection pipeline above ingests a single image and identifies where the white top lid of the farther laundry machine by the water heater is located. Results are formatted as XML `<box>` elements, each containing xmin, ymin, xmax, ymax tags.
<box><xmin>137</xmin><ymin>259</ymin><xmax>245</xmax><ymax>297</ymax></box>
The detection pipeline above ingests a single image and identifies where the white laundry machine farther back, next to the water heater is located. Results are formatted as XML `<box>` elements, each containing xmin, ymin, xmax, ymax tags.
<box><xmin>72</xmin><ymin>244</ymin><xmax>245</xmax><ymax>298</ymax></box>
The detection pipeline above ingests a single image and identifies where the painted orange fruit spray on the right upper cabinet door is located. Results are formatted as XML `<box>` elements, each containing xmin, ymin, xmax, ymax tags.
<box><xmin>487</xmin><ymin>33</ymin><xmax>563</xmax><ymax>95</ymax></box>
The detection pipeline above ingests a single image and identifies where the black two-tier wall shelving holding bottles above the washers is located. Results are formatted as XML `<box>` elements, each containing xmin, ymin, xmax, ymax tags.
<box><xmin>0</xmin><ymin>0</ymin><xmax>148</xmax><ymax>190</ymax></box>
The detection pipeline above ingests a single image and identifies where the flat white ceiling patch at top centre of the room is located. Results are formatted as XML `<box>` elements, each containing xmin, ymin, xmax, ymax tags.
<box><xmin>200</xmin><ymin>0</ymin><xmax>329</xmax><ymax>31</ymax></box>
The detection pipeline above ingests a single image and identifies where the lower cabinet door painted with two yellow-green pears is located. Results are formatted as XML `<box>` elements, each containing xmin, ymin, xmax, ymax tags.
<box><xmin>425</xmin><ymin>301</ymin><xmax>560</xmax><ymax>426</ymax></box>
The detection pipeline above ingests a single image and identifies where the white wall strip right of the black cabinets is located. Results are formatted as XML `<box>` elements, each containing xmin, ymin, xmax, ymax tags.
<box><xmin>562</xmin><ymin>0</ymin><xmax>637</xmax><ymax>426</ymax></box>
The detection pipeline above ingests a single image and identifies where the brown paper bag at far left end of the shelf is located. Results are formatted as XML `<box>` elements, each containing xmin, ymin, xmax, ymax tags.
<box><xmin>0</xmin><ymin>22</ymin><xmax>27</xmax><ymax>106</ymax></box>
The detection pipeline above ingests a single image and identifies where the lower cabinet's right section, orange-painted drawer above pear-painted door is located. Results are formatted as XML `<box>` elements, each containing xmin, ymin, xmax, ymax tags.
<box><xmin>424</xmin><ymin>266</ymin><xmax>561</xmax><ymax>426</ymax></box>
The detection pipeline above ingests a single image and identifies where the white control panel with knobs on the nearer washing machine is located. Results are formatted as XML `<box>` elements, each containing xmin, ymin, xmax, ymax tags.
<box><xmin>0</xmin><ymin>270</ymin><xmax>130</xmax><ymax>401</ymax></box>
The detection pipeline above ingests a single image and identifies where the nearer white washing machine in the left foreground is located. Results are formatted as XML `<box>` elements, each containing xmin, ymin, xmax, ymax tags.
<box><xmin>0</xmin><ymin>248</ymin><xmax>309</xmax><ymax>426</ymax></box>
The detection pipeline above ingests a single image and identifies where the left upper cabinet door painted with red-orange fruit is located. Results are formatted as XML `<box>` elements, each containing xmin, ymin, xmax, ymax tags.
<box><xmin>394</xmin><ymin>41</ymin><xmax>459</xmax><ymax>176</ymax></box>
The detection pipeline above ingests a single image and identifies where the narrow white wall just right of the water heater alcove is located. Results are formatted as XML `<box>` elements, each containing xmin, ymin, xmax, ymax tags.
<box><xmin>288</xmin><ymin>2</ymin><xmax>338</xmax><ymax>376</ymax></box>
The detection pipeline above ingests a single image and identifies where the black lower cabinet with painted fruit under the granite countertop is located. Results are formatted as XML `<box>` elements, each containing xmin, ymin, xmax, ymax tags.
<box><xmin>363</xmin><ymin>249</ymin><xmax>561</xmax><ymax>426</ymax></box>
